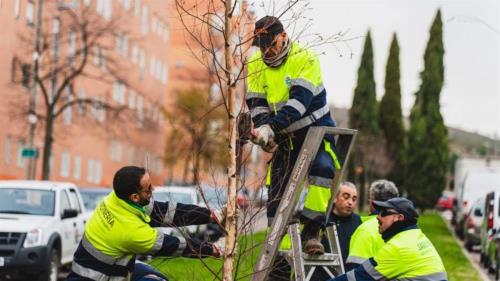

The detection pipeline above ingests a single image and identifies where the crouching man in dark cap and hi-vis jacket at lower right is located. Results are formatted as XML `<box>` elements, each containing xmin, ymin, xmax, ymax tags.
<box><xmin>330</xmin><ymin>197</ymin><xmax>448</xmax><ymax>281</ymax></box>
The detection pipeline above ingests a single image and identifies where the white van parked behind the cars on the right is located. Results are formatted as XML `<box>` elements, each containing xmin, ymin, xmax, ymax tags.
<box><xmin>455</xmin><ymin>168</ymin><xmax>500</xmax><ymax>239</ymax></box>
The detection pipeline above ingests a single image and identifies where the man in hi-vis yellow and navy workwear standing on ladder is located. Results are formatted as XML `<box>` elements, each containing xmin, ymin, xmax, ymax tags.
<box><xmin>246</xmin><ymin>16</ymin><xmax>340</xmax><ymax>260</ymax></box>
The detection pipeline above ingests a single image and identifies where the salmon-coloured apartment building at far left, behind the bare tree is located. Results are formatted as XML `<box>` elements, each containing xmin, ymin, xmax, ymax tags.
<box><xmin>0</xmin><ymin>0</ymin><xmax>173</xmax><ymax>186</ymax></box>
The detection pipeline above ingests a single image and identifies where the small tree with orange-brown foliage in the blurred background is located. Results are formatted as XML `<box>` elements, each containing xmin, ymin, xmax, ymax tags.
<box><xmin>164</xmin><ymin>88</ymin><xmax>226</xmax><ymax>185</ymax></box>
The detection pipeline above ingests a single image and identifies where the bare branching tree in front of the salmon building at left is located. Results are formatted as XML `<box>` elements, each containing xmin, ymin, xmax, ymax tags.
<box><xmin>12</xmin><ymin>2</ymin><xmax>138</xmax><ymax>180</ymax></box>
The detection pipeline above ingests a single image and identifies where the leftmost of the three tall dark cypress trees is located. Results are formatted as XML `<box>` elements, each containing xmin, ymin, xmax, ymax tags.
<box><xmin>349</xmin><ymin>31</ymin><xmax>380</xmax><ymax>210</ymax></box>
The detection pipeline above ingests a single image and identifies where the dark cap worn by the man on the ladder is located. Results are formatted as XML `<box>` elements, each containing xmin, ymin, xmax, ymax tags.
<box><xmin>252</xmin><ymin>16</ymin><xmax>285</xmax><ymax>48</ymax></box>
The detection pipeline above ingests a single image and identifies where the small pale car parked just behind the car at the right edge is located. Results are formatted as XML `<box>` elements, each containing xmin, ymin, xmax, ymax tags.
<box><xmin>463</xmin><ymin>198</ymin><xmax>484</xmax><ymax>251</ymax></box>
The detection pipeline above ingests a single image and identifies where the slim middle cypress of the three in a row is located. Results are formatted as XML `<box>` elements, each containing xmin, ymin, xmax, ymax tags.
<box><xmin>379</xmin><ymin>34</ymin><xmax>406</xmax><ymax>188</ymax></box>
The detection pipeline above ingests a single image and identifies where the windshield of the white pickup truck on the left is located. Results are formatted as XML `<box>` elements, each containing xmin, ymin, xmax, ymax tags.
<box><xmin>0</xmin><ymin>188</ymin><xmax>55</xmax><ymax>216</ymax></box>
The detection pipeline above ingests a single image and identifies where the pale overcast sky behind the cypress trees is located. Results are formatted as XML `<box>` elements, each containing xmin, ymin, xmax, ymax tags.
<box><xmin>255</xmin><ymin>0</ymin><xmax>500</xmax><ymax>138</ymax></box>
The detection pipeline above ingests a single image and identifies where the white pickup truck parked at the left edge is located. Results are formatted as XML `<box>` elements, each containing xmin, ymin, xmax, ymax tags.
<box><xmin>0</xmin><ymin>181</ymin><xmax>86</xmax><ymax>281</ymax></box>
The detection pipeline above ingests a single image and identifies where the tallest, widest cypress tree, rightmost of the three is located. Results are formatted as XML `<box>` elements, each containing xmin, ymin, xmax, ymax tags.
<box><xmin>406</xmin><ymin>10</ymin><xmax>448</xmax><ymax>209</ymax></box>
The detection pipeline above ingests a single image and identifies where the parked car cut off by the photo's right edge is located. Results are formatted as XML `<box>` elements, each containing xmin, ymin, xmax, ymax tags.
<box><xmin>480</xmin><ymin>189</ymin><xmax>500</xmax><ymax>271</ymax></box>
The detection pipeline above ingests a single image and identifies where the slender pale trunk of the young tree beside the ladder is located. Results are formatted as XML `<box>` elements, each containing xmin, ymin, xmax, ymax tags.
<box><xmin>222</xmin><ymin>0</ymin><xmax>238</xmax><ymax>276</ymax></box>
